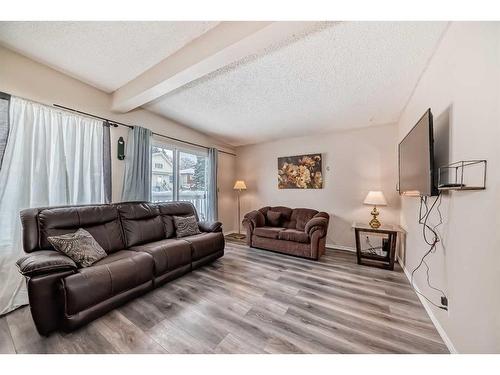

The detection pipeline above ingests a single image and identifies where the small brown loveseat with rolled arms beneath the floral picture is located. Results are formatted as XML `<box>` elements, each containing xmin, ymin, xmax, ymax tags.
<box><xmin>243</xmin><ymin>206</ymin><xmax>330</xmax><ymax>260</ymax></box>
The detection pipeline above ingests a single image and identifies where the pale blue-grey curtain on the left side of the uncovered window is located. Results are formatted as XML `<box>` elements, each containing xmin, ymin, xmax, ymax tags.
<box><xmin>122</xmin><ymin>126</ymin><xmax>153</xmax><ymax>201</ymax></box>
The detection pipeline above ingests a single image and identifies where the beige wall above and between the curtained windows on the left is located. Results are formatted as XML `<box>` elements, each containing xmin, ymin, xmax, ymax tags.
<box><xmin>0</xmin><ymin>47</ymin><xmax>236</xmax><ymax>231</ymax></box>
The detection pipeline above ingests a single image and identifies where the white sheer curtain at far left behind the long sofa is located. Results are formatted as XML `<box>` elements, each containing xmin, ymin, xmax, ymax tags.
<box><xmin>0</xmin><ymin>97</ymin><xmax>105</xmax><ymax>315</ymax></box>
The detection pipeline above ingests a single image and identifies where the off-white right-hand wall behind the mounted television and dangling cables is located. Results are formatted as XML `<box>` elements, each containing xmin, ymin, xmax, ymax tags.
<box><xmin>398</xmin><ymin>22</ymin><xmax>500</xmax><ymax>353</ymax></box>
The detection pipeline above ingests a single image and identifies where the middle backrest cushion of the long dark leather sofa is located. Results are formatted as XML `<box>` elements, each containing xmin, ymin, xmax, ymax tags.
<box><xmin>118</xmin><ymin>202</ymin><xmax>165</xmax><ymax>247</ymax></box>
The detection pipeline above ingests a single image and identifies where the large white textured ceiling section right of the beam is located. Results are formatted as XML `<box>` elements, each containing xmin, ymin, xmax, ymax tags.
<box><xmin>146</xmin><ymin>22</ymin><xmax>446</xmax><ymax>145</ymax></box>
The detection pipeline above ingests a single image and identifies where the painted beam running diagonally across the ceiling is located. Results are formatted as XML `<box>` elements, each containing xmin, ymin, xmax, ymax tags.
<box><xmin>112</xmin><ymin>21</ymin><xmax>316</xmax><ymax>112</ymax></box>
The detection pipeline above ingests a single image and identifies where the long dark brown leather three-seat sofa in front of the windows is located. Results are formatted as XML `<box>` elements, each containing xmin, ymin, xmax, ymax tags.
<box><xmin>18</xmin><ymin>202</ymin><xmax>225</xmax><ymax>335</ymax></box>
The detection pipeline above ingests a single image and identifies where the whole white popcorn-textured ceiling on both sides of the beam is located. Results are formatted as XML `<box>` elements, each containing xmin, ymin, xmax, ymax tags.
<box><xmin>0</xmin><ymin>22</ymin><xmax>447</xmax><ymax>146</ymax></box>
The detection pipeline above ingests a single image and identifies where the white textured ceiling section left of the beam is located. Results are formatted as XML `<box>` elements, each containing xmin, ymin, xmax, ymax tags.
<box><xmin>0</xmin><ymin>22</ymin><xmax>218</xmax><ymax>92</ymax></box>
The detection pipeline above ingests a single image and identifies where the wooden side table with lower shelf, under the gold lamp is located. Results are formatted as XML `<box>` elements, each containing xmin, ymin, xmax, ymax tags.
<box><xmin>352</xmin><ymin>223</ymin><xmax>402</xmax><ymax>271</ymax></box>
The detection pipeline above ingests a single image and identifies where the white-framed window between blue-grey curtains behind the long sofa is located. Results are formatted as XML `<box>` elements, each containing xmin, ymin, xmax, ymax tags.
<box><xmin>151</xmin><ymin>143</ymin><xmax>208</xmax><ymax>220</ymax></box>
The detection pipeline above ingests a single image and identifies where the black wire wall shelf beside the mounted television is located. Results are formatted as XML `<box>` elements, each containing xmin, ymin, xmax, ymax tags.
<box><xmin>438</xmin><ymin>159</ymin><xmax>487</xmax><ymax>191</ymax></box>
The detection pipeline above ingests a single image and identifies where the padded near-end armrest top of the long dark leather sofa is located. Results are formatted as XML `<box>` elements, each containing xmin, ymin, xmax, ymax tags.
<box><xmin>16</xmin><ymin>250</ymin><xmax>78</xmax><ymax>276</ymax></box>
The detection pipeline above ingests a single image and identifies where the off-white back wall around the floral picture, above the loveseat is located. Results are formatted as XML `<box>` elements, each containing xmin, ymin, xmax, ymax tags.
<box><xmin>236</xmin><ymin>124</ymin><xmax>399</xmax><ymax>248</ymax></box>
